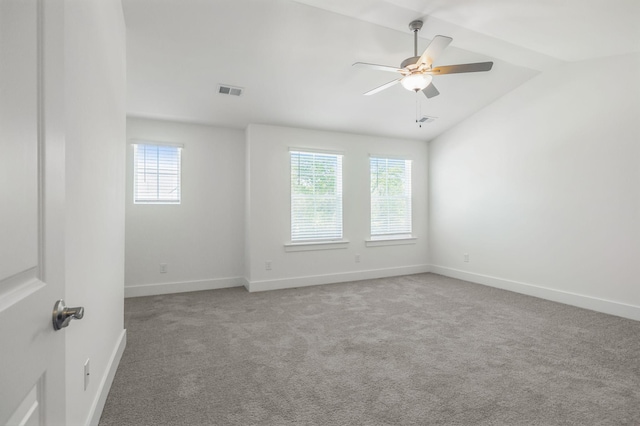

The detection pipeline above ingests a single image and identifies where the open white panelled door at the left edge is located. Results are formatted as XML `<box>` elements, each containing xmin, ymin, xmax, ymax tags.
<box><xmin>0</xmin><ymin>0</ymin><xmax>65</xmax><ymax>425</ymax></box>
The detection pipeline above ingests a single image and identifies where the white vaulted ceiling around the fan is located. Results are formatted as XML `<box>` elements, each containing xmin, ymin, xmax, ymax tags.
<box><xmin>123</xmin><ymin>0</ymin><xmax>640</xmax><ymax>140</ymax></box>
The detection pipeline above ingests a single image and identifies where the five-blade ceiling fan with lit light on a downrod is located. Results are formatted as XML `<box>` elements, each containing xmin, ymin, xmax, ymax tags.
<box><xmin>353</xmin><ymin>20</ymin><xmax>493</xmax><ymax>98</ymax></box>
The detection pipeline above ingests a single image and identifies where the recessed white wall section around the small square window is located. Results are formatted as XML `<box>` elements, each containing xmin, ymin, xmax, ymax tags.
<box><xmin>123</xmin><ymin>117</ymin><xmax>245</xmax><ymax>296</ymax></box>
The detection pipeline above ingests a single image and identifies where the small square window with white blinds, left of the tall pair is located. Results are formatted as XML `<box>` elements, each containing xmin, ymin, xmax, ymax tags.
<box><xmin>133</xmin><ymin>143</ymin><xmax>182</xmax><ymax>204</ymax></box>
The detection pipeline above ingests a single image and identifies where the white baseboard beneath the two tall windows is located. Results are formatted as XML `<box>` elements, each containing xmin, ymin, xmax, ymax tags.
<box><xmin>245</xmin><ymin>265</ymin><xmax>430</xmax><ymax>292</ymax></box>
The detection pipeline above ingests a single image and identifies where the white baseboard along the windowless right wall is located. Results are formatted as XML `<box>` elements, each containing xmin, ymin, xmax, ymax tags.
<box><xmin>431</xmin><ymin>265</ymin><xmax>640</xmax><ymax>321</ymax></box>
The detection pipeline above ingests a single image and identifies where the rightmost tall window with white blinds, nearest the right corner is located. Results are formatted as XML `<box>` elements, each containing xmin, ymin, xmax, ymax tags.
<box><xmin>370</xmin><ymin>157</ymin><xmax>411</xmax><ymax>239</ymax></box>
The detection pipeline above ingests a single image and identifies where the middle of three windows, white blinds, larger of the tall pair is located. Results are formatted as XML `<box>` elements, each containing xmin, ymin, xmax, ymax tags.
<box><xmin>290</xmin><ymin>151</ymin><xmax>342</xmax><ymax>242</ymax></box>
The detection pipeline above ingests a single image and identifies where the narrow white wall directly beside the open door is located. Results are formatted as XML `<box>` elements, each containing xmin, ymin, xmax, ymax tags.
<box><xmin>60</xmin><ymin>0</ymin><xmax>126</xmax><ymax>425</ymax></box>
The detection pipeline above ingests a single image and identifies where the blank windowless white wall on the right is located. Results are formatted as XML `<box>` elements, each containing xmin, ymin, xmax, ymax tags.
<box><xmin>429</xmin><ymin>54</ymin><xmax>640</xmax><ymax>319</ymax></box>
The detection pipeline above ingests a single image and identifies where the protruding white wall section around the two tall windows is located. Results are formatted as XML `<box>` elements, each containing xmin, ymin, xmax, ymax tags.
<box><xmin>245</xmin><ymin>124</ymin><xmax>428</xmax><ymax>291</ymax></box>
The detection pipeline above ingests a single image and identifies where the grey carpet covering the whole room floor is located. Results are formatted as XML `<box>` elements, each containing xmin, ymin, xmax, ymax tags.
<box><xmin>100</xmin><ymin>274</ymin><xmax>640</xmax><ymax>426</ymax></box>
